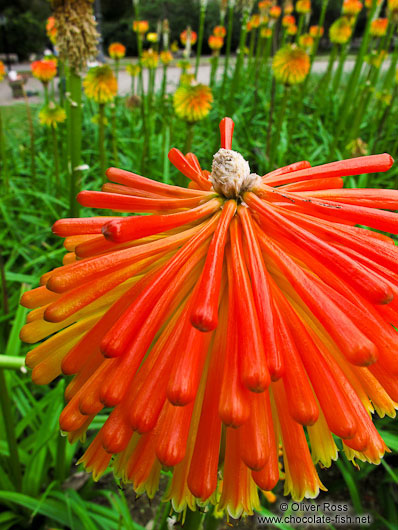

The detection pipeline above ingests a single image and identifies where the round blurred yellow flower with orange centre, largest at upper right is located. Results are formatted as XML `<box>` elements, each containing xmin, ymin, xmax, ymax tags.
<box><xmin>272</xmin><ymin>44</ymin><xmax>310</xmax><ymax>85</ymax></box>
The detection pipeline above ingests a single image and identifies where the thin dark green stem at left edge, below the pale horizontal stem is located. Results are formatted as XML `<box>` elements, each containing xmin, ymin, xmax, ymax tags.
<box><xmin>0</xmin><ymin>370</ymin><xmax>22</xmax><ymax>491</ymax></box>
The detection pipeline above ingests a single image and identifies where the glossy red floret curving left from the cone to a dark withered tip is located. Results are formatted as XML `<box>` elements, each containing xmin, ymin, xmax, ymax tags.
<box><xmin>102</xmin><ymin>199</ymin><xmax>221</xmax><ymax>243</ymax></box>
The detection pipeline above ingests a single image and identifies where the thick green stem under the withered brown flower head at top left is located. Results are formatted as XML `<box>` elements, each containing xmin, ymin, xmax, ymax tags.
<box><xmin>69</xmin><ymin>70</ymin><xmax>82</xmax><ymax>217</ymax></box>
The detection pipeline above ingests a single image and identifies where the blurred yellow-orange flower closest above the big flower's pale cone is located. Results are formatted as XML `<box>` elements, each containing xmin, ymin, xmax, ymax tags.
<box><xmin>173</xmin><ymin>83</ymin><xmax>213</xmax><ymax>123</ymax></box>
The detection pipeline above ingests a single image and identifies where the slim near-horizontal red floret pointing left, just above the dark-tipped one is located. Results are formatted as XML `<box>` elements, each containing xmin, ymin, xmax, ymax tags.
<box><xmin>77</xmin><ymin>191</ymin><xmax>214</xmax><ymax>213</ymax></box>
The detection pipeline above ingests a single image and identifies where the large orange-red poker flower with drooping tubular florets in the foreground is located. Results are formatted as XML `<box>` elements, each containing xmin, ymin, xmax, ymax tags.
<box><xmin>21</xmin><ymin>118</ymin><xmax>398</xmax><ymax>517</ymax></box>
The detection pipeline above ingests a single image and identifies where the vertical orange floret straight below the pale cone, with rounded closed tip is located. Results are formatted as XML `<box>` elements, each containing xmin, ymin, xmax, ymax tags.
<box><xmin>219</xmin><ymin>247</ymin><xmax>250</xmax><ymax>427</ymax></box>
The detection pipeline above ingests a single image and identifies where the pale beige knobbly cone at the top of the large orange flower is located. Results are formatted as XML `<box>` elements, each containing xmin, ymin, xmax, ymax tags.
<box><xmin>209</xmin><ymin>149</ymin><xmax>261</xmax><ymax>199</ymax></box>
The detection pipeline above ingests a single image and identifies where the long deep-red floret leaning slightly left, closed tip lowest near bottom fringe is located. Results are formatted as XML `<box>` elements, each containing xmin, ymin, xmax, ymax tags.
<box><xmin>188</xmin><ymin>294</ymin><xmax>228</xmax><ymax>501</ymax></box>
